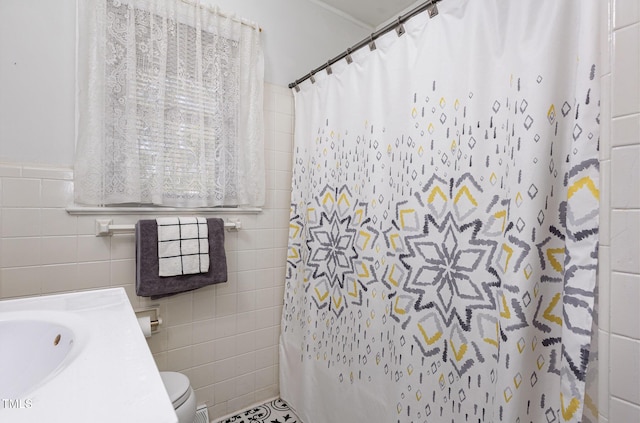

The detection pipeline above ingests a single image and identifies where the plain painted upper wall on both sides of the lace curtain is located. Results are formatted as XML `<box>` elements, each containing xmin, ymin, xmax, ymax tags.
<box><xmin>0</xmin><ymin>0</ymin><xmax>371</xmax><ymax>165</ymax></box>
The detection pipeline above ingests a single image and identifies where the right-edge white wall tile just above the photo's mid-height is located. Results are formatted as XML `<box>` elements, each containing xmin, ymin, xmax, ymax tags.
<box><xmin>611</xmin><ymin>144</ymin><xmax>640</xmax><ymax>209</ymax></box>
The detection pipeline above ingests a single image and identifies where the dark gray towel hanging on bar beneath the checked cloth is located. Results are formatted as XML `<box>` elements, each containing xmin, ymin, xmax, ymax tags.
<box><xmin>136</xmin><ymin>218</ymin><xmax>227</xmax><ymax>299</ymax></box>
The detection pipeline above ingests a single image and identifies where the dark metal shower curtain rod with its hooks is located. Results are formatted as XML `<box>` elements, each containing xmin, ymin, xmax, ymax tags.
<box><xmin>289</xmin><ymin>0</ymin><xmax>442</xmax><ymax>90</ymax></box>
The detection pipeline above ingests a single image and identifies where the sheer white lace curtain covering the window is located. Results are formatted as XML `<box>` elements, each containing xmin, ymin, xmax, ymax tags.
<box><xmin>74</xmin><ymin>0</ymin><xmax>265</xmax><ymax>207</ymax></box>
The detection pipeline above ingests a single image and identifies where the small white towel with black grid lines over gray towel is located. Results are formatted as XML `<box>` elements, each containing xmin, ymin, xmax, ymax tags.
<box><xmin>156</xmin><ymin>217</ymin><xmax>209</xmax><ymax>276</ymax></box>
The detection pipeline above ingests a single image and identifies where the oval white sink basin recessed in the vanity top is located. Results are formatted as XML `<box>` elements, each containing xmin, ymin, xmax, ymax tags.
<box><xmin>0</xmin><ymin>312</ymin><xmax>83</xmax><ymax>398</ymax></box>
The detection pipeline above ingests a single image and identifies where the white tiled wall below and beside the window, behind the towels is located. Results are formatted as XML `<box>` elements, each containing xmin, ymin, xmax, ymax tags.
<box><xmin>0</xmin><ymin>84</ymin><xmax>293</xmax><ymax>419</ymax></box>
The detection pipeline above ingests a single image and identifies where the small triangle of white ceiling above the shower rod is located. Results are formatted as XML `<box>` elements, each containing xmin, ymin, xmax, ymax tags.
<box><xmin>315</xmin><ymin>0</ymin><xmax>416</xmax><ymax>28</ymax></box>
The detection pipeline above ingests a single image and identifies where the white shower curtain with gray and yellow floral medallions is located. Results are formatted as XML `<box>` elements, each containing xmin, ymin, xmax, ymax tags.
<box><xmin>280</xmin><ymin>0</ymin><xmax>599</xmax><ymax>423</ymax></box>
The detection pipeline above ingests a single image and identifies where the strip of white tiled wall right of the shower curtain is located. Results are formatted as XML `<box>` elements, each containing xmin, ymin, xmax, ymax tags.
<box><xmin>598</xmin><ymin>0</ymin><xmax>640</xmax><ymax>423</ymax></box>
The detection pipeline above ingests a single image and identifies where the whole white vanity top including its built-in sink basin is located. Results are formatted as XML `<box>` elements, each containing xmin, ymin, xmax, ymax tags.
<box><xmin>0</xmin><ymin>288</ymin><xmax>178</xmax><ymax>423</ymax></box>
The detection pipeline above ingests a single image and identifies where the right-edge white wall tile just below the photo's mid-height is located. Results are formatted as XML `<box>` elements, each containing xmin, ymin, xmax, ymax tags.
<box><xmin>611</xmin><ymin>210</ymin><xmax>640</xmax><ymax>273</ymax></box>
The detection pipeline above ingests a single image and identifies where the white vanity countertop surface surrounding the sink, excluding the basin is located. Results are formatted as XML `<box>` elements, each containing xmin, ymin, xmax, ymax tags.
<box><xmin>0</xmin><ymin>288</ymin><xmax>177</xmax><ymax>423</ymax></box>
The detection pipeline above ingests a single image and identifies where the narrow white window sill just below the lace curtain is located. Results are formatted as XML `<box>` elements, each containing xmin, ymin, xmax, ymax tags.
<box><xmin>67</xmin><ymin>205</ymin><xmax>262</xmax><ymax>216</ymax></box>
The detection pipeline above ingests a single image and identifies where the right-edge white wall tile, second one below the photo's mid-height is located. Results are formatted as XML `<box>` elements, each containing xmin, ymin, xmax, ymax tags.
<box><xmin>611</xmin><ymin>272</ymin><xmax>640</xmax><ymax>340</ymax></box>
